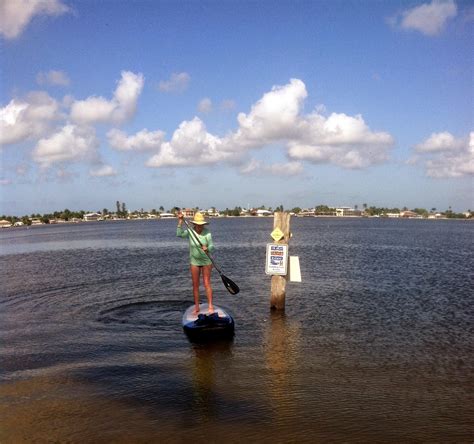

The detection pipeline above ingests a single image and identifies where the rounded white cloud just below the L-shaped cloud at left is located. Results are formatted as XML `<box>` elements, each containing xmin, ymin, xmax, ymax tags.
<box><xmin>33</xmin><ymin>124</ymin><xmax>99</xmax><ymax>168</ymax></box>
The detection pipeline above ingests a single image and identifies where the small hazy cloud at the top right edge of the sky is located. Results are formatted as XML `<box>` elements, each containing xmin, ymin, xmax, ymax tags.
<box><xmin>393</xmin><ymin>0</ymin><xmax>457</xmax><ymax>36</ymax></box>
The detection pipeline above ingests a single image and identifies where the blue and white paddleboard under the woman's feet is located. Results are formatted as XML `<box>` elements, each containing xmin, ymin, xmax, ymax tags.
<box><xmin>183</xmin><ymin>304</ymin><xmax>234</xmax><ymax>340</ymax></box>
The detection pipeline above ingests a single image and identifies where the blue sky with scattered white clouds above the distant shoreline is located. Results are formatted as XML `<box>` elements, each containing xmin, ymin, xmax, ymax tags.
<box><xmin>0</xmin><ymin>0</ymin><xmax>474</xmax><ymax>216</ymax></box>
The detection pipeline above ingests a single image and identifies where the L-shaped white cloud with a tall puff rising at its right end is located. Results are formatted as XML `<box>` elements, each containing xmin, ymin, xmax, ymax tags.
<box><xmin>71</xmin><ymin>71</ymin><xmax>144</xmax><ymax>124</ymax></box>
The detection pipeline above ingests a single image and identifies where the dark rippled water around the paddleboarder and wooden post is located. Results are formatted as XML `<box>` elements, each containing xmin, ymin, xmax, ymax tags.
<box><xmin>0</xmin><ymin>218</ymin><xmax>474</xmax><ymax>443</ymax></box>
